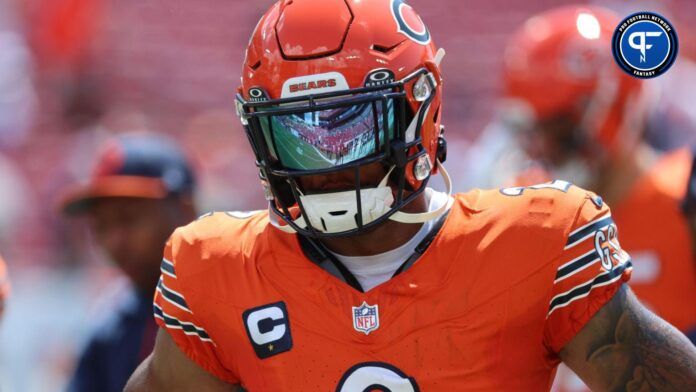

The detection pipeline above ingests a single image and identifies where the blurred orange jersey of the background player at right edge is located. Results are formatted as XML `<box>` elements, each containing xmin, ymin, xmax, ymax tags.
<box><xmin>613</xmin><ymin>149</ymin><xmax>696</xmax><ymax>331</ymax></box>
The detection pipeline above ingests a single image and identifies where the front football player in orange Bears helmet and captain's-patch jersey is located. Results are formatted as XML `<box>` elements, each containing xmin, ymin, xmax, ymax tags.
<box><xmin>126</xmin><ymin>0</ymin><xmax>696</xmax><ymax>391</ymax></box>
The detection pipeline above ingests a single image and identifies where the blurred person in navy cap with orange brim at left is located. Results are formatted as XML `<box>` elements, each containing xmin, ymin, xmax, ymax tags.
<box><xmin>62</xmin><ymin>134</ymin><xmax>196</xmax><ymax>392</ymax></box>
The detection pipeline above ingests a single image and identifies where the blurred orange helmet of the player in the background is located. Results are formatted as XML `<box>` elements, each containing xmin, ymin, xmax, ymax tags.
<box><xmin>504</xmin><ymin>5</ymin><xmax>647</xmax><ymax>182</ymax></box>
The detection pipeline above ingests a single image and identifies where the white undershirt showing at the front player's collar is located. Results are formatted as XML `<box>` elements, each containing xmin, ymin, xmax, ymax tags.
<box><xmin>331</xmin><ymin>188</ymin><xmax>448</xmax><ymax>291</ymax></box>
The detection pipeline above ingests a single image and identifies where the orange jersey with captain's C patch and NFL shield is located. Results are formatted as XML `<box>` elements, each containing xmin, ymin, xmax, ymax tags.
<box><xmin>154</xmin><ymin>182</ymin><xmax>631</xmax><ymax>391</ymax></box>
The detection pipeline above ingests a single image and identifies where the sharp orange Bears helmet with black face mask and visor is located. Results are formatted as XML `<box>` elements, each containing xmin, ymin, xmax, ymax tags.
<box><xmin>237</xmin><ymin>0</ymin><xmax>445</xmax><ymax>237</ymax></box>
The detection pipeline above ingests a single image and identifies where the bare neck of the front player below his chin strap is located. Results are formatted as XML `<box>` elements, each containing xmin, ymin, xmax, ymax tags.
<box><xmin>322</xmin><ymin>192</ymin><xmax>428</xmax><ymax>256</ymax></box>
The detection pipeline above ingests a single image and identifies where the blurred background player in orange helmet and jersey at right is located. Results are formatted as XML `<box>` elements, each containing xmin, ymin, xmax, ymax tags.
<box><xmin>490</xmin><ymin>6</ymin><xmax>696</xmax><ymax>389</ymax></box>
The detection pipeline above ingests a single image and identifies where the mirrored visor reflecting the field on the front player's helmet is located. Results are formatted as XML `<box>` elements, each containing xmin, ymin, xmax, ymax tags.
<box><xmin>259</xmin><ymin>98</ymin><xmax>395</xmax><ymax>170</ymax></box>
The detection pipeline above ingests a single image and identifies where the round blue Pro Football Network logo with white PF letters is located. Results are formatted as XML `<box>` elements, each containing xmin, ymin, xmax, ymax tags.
<box><xmin>612</xmin><ymin>12</ymin><xmax>679</xmax><ymax>79</ymax></box>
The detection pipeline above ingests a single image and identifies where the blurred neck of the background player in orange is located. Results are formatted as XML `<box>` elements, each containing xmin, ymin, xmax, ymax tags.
<box><xmin>595</xmin><ymin>144</ymin><xmax>656</xmax><ymax>206</ymax></box>
